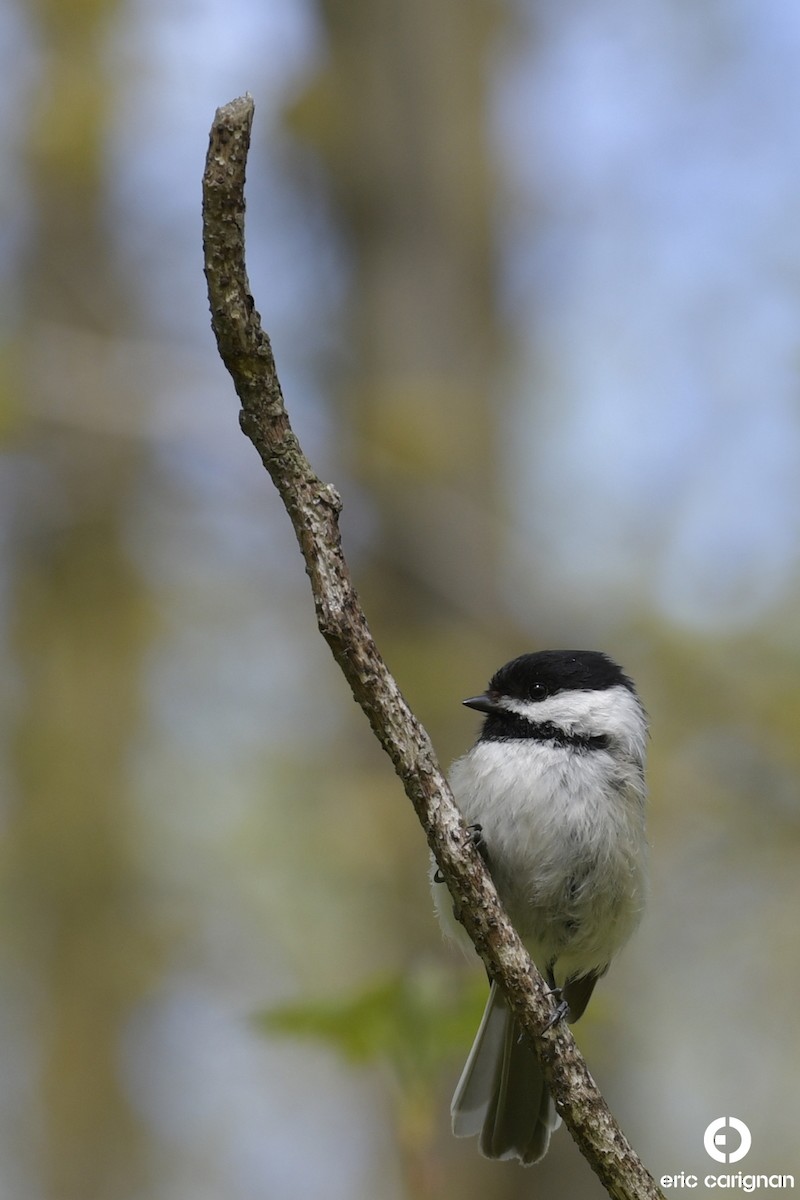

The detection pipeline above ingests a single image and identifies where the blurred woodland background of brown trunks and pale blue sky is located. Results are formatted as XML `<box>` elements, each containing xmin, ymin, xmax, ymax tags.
<box><xmin>0</xmin><ymin>0</ymin><xmax>800</xmax><ymax>1200</ymax></box>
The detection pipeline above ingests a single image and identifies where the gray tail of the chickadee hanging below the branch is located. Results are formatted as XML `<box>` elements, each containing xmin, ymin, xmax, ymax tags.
<box><xmin>450</xmin><ymin>983</ymin><xmax>561</xmax><ymax>1166</ymax></box>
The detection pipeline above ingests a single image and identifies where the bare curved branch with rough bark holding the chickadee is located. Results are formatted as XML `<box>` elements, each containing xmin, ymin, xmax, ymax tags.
<box><xmin>203</xmin><ymin>96</ymin><xmax>663</xmax><ymax>1200</ymax></box>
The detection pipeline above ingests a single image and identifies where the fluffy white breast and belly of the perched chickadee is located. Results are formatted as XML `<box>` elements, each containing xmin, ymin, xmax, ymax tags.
<box><xmin>450</xmin><ymin>729</ymin><xmax>646</xmax><ymax>979</ymax></box>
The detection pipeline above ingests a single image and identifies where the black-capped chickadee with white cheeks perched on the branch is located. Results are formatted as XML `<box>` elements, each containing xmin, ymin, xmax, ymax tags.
<box><xmin>433</xmin><ymin>650</ymin><xmax>648</xmax><ymax>1165</ymax></box>
